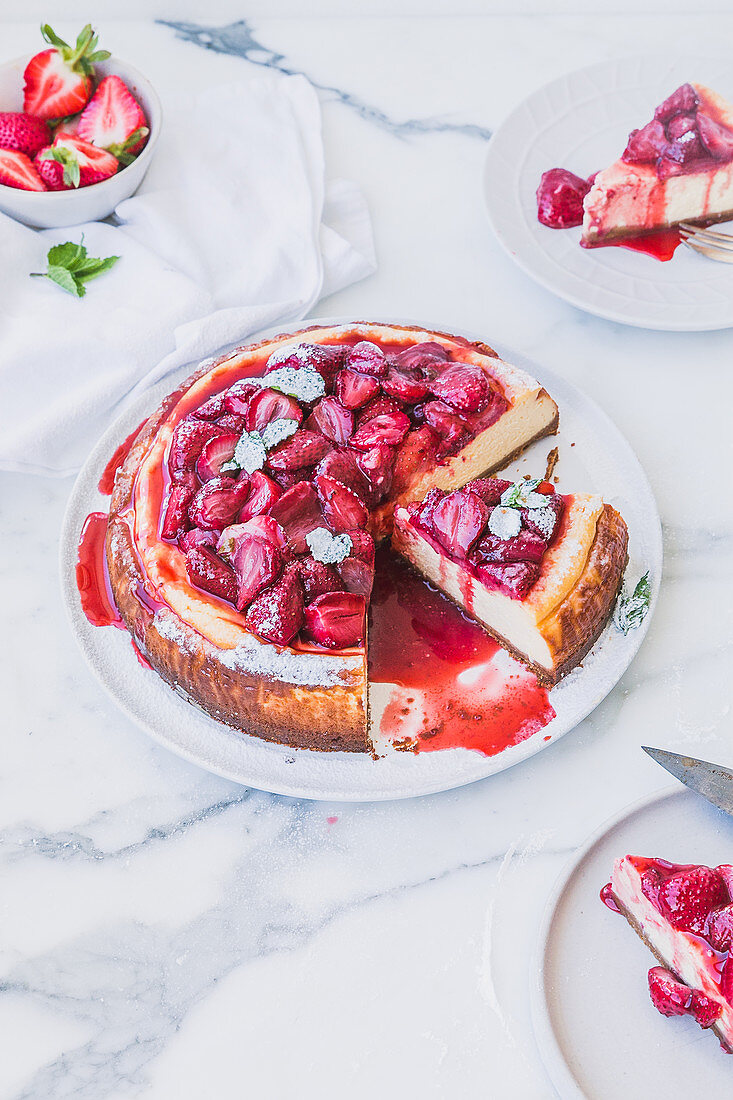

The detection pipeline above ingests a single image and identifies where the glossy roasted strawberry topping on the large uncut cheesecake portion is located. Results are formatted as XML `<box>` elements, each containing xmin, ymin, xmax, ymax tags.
<box><xmin>161</xmin><ymin>340</ymin><xmax>506</xmax><ymax>649</ymax></box>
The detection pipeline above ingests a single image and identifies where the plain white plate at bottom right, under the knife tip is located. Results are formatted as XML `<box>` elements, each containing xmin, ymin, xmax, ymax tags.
<box><xmin>532</xmin><ymin>787</ymin><xmax>733</xmax><ymax>1100</ymax></box>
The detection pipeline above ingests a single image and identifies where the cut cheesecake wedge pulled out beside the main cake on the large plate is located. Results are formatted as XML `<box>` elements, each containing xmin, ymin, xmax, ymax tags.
<box><xmin>392</xmin><ymin>479</ymin><xmax>627</xmax><ymax>684</ymax></box>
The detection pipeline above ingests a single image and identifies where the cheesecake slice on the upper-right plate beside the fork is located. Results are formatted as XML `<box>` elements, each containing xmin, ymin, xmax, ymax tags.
<box><xmin>581</xmin><ymin>84</ymin><xmax>733</xmax><ymax>246</ymax></box>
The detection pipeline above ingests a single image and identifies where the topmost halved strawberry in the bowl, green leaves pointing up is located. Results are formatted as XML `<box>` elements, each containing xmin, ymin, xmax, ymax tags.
<box><xmin>23</xmin><ymin>23</ymin><xmax>110</xmax><ymax>119</ymax></box>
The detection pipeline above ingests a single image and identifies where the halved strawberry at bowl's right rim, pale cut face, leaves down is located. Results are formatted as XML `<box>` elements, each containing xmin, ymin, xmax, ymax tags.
<box><xmin>78</xmin><ymin>75</ymin><xmax>150</xmax><ymax>164</ymax></box>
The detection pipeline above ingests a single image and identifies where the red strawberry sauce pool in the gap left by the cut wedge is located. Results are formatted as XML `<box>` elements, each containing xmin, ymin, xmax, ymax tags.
<box><xmin>369</xmin><ymin>550</ymin><xmax>555</xmax><ymax>756</ymax></box>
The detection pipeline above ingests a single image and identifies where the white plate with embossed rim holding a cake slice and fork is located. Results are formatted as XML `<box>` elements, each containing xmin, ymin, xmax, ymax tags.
<box><xmin>484</xmin><ymin>56</ymin><xmax>733</xmax><ymax>331</ymax></box>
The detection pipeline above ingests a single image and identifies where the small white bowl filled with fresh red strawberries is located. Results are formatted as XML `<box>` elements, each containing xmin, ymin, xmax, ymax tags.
<box><xmin>0</xmin><ymin>24</ymin><xmax>162</xmax><ymax>229</ymax></box>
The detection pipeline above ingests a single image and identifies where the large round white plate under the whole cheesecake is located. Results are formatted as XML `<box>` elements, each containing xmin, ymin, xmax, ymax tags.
<box><xmin>61</xmin><ymin>319</ymin><xmax>661</xmax><ymax>801</ymax></box>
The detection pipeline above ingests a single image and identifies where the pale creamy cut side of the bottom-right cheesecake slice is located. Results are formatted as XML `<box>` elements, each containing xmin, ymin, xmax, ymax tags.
<box><xmin>611</xmin><ymin>857</ymin><xmax>733</xmax><ymax>1045</ymax></box>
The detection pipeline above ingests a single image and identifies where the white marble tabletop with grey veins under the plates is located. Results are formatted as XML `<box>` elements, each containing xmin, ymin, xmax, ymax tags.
<box><xmin>0</xmin><ymin>17</ymin><xmax>733</xmax><ymax>1100</ymax></box>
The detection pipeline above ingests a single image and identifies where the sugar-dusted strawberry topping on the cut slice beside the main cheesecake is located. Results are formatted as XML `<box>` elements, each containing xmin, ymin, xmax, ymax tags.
<box><xmin>407</xmin><ymin>477</ymin><xmax>565</xmax><ymax>600</ymax></box>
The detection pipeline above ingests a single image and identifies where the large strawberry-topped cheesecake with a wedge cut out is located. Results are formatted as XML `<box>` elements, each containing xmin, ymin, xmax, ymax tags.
<box><xmin>106</xmin><ymin>322</ymin><xmax>558</xmax><ymax>752</ymax></box>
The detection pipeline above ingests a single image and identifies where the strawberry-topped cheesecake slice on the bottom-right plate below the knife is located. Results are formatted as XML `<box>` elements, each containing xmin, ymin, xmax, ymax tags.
<box><xmin>601</xmin><ymin>856</ymin><xmax>733</xmax><ymax>1054</ymax></box>
